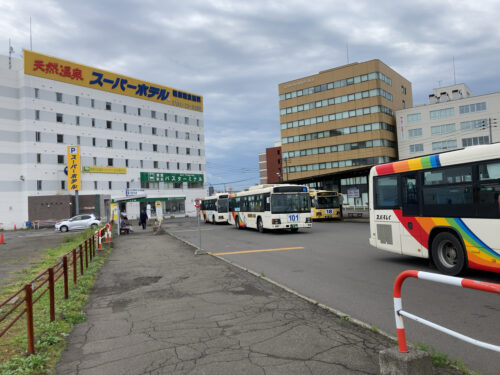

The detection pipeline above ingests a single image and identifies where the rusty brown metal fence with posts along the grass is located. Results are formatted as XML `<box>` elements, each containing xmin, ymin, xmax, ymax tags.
<box><xmin>0</xmin><ymin>224</ymin><xmax>111</xmax><ymax>354</ymax></box>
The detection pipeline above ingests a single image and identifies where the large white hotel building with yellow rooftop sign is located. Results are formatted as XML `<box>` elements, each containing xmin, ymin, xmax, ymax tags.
<box><xmin>0</xmin><ymin>51</ymin><xmax>205</xmax><ymax>229</ymax></box>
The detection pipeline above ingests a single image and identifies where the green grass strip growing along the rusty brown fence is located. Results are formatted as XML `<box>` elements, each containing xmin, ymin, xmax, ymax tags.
<box><xmin>0</xmin><ymin>230</ymin><xmax>110</xmax><ymax>375</ymax></box>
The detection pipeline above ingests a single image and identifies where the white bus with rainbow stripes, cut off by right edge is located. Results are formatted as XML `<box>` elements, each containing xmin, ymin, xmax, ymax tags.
<box><xmin>370</xmin><ymin>143</ymin><xmax>500</xmax><ymax>275</ymax></box>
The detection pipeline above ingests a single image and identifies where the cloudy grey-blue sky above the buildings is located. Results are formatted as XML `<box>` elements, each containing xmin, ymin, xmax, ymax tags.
<box><xmin>0</xmin><ymin>0</ymin><xmax>500</xmax><ymax>189</ymax></box>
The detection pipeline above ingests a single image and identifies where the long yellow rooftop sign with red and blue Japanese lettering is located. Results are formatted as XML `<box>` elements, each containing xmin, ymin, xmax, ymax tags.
<box><xmin>24</xmin><ymin>50</ymin><xmax>203</xmax><ymax>112</ymax></box>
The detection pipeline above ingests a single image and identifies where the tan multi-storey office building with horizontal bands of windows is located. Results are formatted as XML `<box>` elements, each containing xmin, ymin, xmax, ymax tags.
<box><xmin>279</xmin><ymin>60</ymin><xmax>413</xmax><ymax>207</ymax></box>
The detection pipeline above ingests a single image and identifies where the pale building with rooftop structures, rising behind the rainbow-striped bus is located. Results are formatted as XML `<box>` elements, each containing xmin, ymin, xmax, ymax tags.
<box><xmin>396</xmin><ymin>84</ymin><xmax>500</xmax><ymax>160</ymax></box>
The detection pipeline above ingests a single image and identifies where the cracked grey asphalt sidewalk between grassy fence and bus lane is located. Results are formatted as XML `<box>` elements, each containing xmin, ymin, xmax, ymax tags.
<box><xmin>56</xmin><ymin>231</ymin><xmax>458</xmax><ymax>375</ymax></box>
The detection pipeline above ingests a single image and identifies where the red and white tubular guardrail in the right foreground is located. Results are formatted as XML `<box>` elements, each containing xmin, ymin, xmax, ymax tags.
<box><xmin>393</xmin><ymin>270</ymin><xmax>500</xmax><ymax>353</ymax></box>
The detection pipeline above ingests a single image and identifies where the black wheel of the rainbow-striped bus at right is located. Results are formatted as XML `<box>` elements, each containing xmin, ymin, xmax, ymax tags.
<box><xmin>432</xmin><ymin>232</ymin><xmax>465</xmax><ymax>276</ymax></box>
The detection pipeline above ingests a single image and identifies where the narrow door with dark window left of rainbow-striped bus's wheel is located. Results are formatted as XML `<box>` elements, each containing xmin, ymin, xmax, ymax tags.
<box><xmin>401</xmin><ymin>173</ymin><xmax>427</xmax><ymax>257</ymax></box>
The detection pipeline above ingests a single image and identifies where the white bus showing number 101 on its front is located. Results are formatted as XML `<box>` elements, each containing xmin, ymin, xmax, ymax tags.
<box><xmin>229</xmin><ymin>185</ymin><xmax>311</xmax><ymax>233</ymax></box>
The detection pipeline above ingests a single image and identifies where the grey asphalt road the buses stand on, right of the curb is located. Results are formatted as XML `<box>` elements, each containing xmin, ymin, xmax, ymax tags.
<box><xmin>166</xmin><ymin>219</ymin><xmax>500</xmax><ymax>374</ymax></box>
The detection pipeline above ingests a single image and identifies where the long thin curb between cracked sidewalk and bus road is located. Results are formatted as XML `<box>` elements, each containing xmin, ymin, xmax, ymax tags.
<box><xmin>167</xmin><ymin>231</ymin><xmax>398</xmax><ymax>342</ymax></box>
